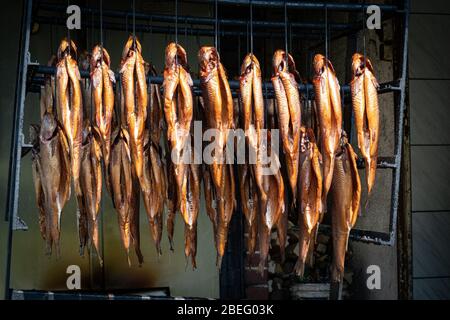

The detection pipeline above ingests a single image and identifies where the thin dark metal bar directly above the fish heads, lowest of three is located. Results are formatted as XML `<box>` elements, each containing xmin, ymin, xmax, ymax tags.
<box><xmin>33</xmin><ymin>16</ymin><xmax>326</xmax><ymax>40</ymax></box>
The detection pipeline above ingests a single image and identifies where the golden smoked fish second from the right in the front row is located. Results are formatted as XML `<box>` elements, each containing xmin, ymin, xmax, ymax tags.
<box><xmin>313</xmin><ymin>54</ymin><xmax>342</xmax><ymax>212</ymax></box>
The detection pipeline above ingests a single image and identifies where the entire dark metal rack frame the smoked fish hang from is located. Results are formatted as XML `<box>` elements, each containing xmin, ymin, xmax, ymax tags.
<box><xmin>5</xmin><ymin>0</ymin><xmax>409</xmax><ymax>298</ymax></box>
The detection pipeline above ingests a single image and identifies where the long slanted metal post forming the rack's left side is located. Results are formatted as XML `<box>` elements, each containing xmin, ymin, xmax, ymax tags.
<box><xmin>4</xmin><ymin>0</ymin><xmax>33</xmax><ymax>299</ymax></box>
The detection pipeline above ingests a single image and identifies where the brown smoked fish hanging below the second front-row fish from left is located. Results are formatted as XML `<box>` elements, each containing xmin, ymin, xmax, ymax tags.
<box><xmin>80</xmin><ymin>120</ymin><xmax>103</xmax><ymax>265</ymax></box>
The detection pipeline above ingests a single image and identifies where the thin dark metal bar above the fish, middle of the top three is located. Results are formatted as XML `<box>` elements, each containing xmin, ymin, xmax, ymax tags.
<box><xmin>39</xmin><ymin>1</ymin><xmax>361</xmax><ymax>30</ymax></box>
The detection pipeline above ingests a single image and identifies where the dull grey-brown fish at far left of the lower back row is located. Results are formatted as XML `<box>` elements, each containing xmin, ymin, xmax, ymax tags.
<box><xmin>31</xmin><ymin>112</ymin><xmax>70</xmax><ymax>257</ymax></box>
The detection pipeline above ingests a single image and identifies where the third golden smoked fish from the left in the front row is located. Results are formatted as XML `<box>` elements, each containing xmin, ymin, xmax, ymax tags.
<box><xmin>120</xmin><ymin>36</ymin><xmax>148</xmax><ymax>194</ymax></box>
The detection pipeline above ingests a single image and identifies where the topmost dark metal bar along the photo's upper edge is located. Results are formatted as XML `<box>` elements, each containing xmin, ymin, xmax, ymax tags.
<box><xmin>190</xmin><ymin>0</ymin><xmax>404</xmax><ymax>12</ymax></box>
